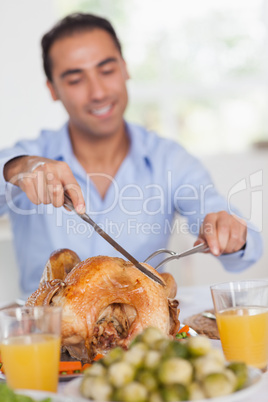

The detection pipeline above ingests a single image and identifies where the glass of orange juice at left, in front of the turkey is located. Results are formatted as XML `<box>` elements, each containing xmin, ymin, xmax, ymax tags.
<box><xmin>0</xmin><ymin>306</ymin><xmax>61</xmax><ymax>392</ymax></box>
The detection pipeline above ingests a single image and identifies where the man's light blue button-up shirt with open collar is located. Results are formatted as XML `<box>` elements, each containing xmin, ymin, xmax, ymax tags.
<box><xmin>0</xmin><ymin>123</ymin><xmax>262</xmax><ymax>294</ymax></box>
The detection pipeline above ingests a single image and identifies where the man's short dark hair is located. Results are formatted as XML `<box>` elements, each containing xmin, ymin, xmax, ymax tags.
<box><xmin>41</xmin><ymin>13</ymin><xmax>122</xmax><ymax>81</ymax></box>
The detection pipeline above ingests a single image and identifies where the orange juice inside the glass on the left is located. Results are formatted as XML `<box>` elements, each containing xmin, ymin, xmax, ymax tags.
<box><xmin>1</xmin><ymin>334</ymin><xmax>60</xmax><ymax>392</ymax></box>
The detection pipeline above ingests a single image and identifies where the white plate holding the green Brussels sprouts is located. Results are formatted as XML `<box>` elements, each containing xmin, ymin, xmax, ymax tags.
<box><xmin>63</xmin><ymin>368</ymin><xmax>263</xmax><ymax>402</ymax></box>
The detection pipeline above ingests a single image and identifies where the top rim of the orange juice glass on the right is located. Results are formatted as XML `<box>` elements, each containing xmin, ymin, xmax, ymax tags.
<box><xmin>210</xmin><ymin>279</ymin><xmax>268</xmax><ymax>292</ymax></box>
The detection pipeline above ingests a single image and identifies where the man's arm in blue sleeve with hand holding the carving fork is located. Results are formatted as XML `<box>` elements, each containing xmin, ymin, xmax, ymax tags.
<box><xmin>163</xmin><ymin>141</ymin><xmax>263</xmax><ymax>272</ymax></box>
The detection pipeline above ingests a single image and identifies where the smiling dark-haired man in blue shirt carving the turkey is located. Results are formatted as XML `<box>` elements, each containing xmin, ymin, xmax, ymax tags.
<box><xmin>0</xmin><ymin>14</ymin><xmax>262</xmax><ymax>294</ymax></box>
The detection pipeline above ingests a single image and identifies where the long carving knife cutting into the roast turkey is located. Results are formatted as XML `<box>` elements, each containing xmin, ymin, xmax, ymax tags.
<box><xmin>64</xmin><ymin>193</ymin><xmax>165</xmax><ymax>286</ymax></box>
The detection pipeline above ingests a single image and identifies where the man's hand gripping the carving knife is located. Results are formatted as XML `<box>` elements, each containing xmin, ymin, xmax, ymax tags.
<box><xmin>4</xmin><ymin>156</ymin><xmax>85</xmax><ymax>214</ymax></box>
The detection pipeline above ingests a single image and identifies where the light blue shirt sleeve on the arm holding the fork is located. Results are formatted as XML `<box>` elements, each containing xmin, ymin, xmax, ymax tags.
<box><xmin>169</xmin><ymin>143</ymin><xmax>263</xmax><ymax>272</ymax></box>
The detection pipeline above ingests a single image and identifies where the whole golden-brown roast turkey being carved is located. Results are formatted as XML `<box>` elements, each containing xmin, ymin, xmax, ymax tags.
<box><xmin>26</xmin><ymin>249</ymin><xmax>180</xmax><ymax>362</ymax></box>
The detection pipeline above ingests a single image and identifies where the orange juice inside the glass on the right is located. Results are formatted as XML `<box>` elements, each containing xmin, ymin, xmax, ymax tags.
<box><xmin>216</xmin><ymin>307</ymin><xmax>268</xmax><ymax>369</ymax></box>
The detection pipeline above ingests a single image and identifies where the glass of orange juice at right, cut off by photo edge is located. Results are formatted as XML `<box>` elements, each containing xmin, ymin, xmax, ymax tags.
<box><xmin>210</xmin><ymin>280</ymin><xmax>268</xmax><ymax>371</ymax></box>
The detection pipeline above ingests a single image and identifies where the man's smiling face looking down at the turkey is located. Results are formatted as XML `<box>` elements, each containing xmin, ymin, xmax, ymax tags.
<box><xmin>48</xmin><ymin>29</ymin><xmax>129</xmax><ymax>138</ymax></box>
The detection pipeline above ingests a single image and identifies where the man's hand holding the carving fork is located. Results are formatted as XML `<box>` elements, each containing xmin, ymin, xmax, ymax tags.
<box><xmin>195</xmin><ymin>211</ymin><xmax>247</xmax><ymax>256</ymax></box>
